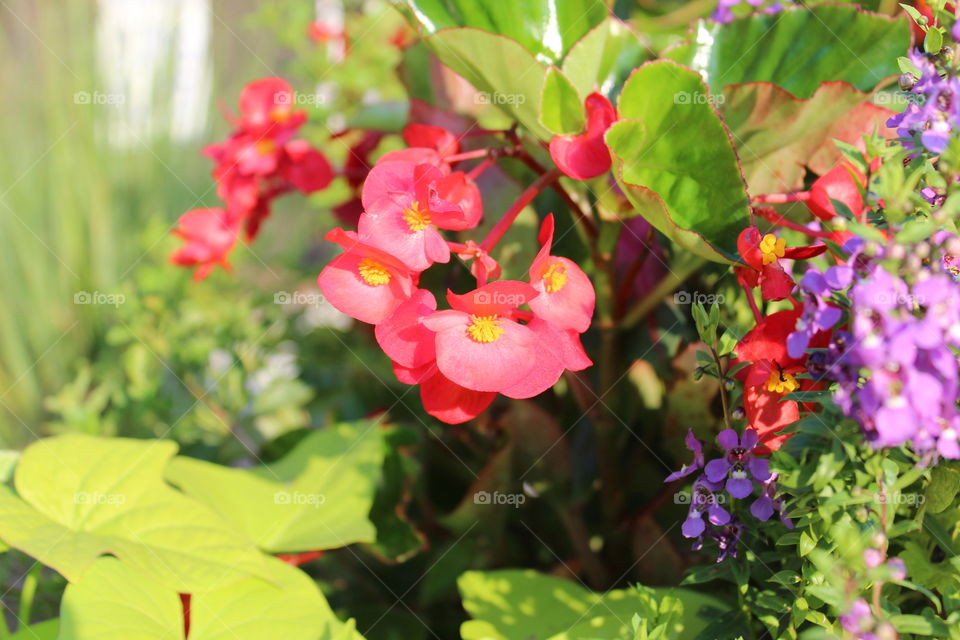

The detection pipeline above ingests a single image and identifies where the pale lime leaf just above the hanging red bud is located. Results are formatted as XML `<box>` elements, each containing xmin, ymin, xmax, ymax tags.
<box><xmin>561</xmin><ymin>16</ymin><xmax>649</xmax><ymax>100</ymax></box>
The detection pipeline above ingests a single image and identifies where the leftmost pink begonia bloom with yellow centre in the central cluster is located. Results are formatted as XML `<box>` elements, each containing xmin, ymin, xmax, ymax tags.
<box><xmin>317</xmin><ymin>228</ymin><xmax>414</xmax><ymax>324</ymax></box>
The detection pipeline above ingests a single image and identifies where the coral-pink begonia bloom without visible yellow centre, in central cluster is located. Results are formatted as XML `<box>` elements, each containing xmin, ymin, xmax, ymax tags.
<box><xmin>374</xmin><ymin>289</ymin><xmax>437</xmax><ymax>368</ymax></box>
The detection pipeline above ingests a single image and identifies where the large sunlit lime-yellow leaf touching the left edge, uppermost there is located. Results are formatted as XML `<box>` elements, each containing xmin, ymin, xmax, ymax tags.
<box><xmin>0</xmin><ymin>435</ymin><xmax>264</xmax><ymax>592</ymax></box>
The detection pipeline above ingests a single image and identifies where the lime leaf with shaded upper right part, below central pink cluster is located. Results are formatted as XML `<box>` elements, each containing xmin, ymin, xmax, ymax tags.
<box><xmin>167</xmin><ymin>422</ymin><xmax>384</xmax><ymax>553</ymax></box>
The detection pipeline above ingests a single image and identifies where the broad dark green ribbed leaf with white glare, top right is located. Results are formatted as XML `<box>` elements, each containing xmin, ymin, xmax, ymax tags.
<box><xmin>666</xmin><ymin>5</ymin><xmax>910</xmax><ymax>98</ymax></box>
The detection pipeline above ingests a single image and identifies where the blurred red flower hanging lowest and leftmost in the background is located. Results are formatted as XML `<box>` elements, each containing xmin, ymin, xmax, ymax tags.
<box><xmin>170</xmin><ymin>209</ymin><xmax>238</xmax><ymax>280</ymax></box>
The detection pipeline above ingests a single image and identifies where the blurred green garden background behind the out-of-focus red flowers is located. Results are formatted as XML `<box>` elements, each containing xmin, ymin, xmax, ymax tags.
<box><xmin>0</xmin><ymin>0</ymin><xmax>403</xmax><ymax>448</ymax></box>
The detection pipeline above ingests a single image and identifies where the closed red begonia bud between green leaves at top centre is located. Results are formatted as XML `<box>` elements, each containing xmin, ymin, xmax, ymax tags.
<box><xmin>550</xmin><ymin>93</ymin><xmax>617</xmax><ymax>180</ymax></box>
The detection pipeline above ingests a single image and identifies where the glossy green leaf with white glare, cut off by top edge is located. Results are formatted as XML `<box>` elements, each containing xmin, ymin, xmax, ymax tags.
<box><xmin>399</xmin><ymin>0</ymin><xmax>610</xmax><ymax>65</ymax></box>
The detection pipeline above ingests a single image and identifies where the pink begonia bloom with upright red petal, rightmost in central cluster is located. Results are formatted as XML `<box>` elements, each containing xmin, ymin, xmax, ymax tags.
<box><xmin>530</xmin><ymin>214</ymin><xmax>596</xmax><ymax>333</ymax></box>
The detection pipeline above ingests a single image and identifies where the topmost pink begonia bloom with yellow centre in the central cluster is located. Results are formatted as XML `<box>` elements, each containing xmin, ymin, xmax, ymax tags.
<box><xmin>357</xmin><ymin>162</ymin><xmax>464</xmax><ymax>272</ymax></box>
